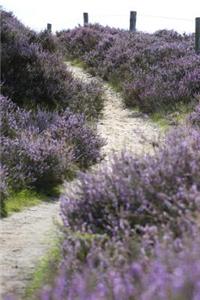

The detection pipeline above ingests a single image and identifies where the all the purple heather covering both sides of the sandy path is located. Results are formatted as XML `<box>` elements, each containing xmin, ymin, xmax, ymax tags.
<box><xmin>1</xmin><ymin>12</ymin><xmax>200</xmax><ymax>300</ymax></box>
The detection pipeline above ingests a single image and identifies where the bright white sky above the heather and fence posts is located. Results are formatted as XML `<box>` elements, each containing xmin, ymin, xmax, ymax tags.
<box><xmin>1</xmin><ymin>0</ymin><xmax>200</xmax><ymax>33</ymax></box>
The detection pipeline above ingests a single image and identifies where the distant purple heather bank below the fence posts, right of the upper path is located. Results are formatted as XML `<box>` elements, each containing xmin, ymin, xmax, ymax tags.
<box><xmin>59</xmin><ymin>25</ymin><xmax>200</xmax><ymax>112</ymax></box>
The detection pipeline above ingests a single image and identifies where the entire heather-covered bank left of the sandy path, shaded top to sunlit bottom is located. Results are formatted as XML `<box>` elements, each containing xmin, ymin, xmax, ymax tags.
<box><xmin>0</xmin><ymin>11</ymin><xmax>103</xmax><ymax>215</ymax></box>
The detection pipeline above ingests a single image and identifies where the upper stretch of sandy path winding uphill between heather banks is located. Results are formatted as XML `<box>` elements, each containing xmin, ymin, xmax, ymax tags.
<box><xmin>66</xmin><ymin>63</ymin><xmax>160</xmax><ymax>159</ymax></box>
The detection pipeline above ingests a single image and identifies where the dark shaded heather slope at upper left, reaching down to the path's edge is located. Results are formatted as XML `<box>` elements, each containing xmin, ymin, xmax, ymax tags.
<box><xmin>1</xmin><ymin>11</ymin><xmax>103</xmax><ymax>119</ymax></box>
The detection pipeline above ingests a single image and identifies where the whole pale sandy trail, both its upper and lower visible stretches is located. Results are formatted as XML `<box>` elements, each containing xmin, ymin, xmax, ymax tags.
<box><xmin>0</xmin><ymin>63</ymin><xmax>159</xmax><ymax>300</ymax></box>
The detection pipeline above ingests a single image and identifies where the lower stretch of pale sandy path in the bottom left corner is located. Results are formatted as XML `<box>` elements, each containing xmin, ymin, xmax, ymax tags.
<box><xmin>0</xmin><ymin>201</ymin><xmax>59</xmax><ymax>299</ymax></box>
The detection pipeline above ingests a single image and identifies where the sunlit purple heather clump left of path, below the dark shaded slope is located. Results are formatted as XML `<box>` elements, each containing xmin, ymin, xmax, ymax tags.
<box><xmin>0</xmin><ymin>96</ymin><xmax>102</xmax><ymax>190</ymax></box>
